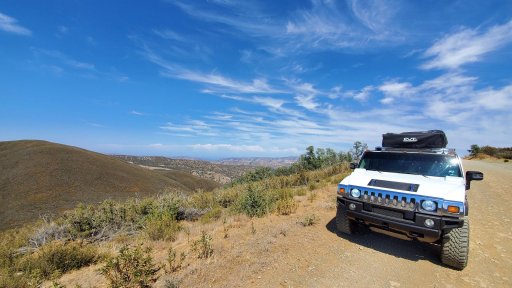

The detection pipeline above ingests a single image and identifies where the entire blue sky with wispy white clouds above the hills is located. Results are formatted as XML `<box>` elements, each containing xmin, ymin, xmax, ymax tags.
<box><xmin>0</xmin><ymin>0</ymin><xmax>512</xmax><ymax>158</ymax></box>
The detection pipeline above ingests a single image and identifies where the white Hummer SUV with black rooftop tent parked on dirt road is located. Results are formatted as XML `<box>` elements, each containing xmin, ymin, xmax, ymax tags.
<box><xmin>336</xmin><ymin>130</ymin><xmax>483</xmax><ymax>270</ymax></box>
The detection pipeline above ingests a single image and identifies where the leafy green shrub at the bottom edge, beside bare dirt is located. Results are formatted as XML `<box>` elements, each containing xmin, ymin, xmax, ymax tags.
<box><xmin>100</xmin><ymin>245</ymin><xmax>160</xmax><ymax>288</ymax></box>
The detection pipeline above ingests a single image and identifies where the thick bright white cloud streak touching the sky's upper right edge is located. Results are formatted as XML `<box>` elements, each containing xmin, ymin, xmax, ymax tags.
<box><xmin>420</xmin><ymin>20</ymin><xmax>512</xmax><ymax>70</ymax></box>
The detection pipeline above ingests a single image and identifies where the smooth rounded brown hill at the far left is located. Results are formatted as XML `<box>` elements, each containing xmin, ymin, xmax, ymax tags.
<box><xmin>0</xmin><ymin>141</ymin><xmax>218</xmax><ymax>229</ymax></box>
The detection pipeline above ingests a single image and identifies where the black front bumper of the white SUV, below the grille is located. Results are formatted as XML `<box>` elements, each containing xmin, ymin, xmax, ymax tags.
<box><xmin>337</xmin><ymin>196</ymin><xmax>464</xmax><ymax>242</ymax></box>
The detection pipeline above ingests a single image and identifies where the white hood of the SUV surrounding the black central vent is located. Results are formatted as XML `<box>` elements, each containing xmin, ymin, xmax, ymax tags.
<box><xmin>340</xmin><ymin>168</ymin><xmax>466</xmax><ymax>203</ymax></box>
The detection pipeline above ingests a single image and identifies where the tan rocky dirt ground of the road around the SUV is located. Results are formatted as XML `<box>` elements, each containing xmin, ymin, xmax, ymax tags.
<box><xmin>55</xmin><ymin>160</ymin><xmax>512</xmax><ymax>287</ymax></box>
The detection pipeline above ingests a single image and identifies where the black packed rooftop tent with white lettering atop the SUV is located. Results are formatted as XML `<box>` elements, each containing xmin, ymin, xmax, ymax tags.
<box><xmin>382</xmin><ymin>130</ymin><xmax>448</xmax><ymax>149</ymax></box>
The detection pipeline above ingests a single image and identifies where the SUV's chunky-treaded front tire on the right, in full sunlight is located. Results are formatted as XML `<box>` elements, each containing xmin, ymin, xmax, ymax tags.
<box><xmin>441</xmin><ymin>218</ymin><xmax>469</xmax><ymax>270</ymax></box>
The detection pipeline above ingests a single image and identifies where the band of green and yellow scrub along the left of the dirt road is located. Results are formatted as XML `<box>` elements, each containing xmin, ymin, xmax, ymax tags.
<box><xmin>0</xmin><ymin>142</ymin><xmax>364</xmax><ymax>287</ymax></box>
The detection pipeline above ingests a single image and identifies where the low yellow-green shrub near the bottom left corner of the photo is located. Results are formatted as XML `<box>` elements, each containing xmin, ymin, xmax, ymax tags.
<box><xmin>19</xmin><ymin>242</ymin><xmax>99</xmax><ymax>279</ymax></box>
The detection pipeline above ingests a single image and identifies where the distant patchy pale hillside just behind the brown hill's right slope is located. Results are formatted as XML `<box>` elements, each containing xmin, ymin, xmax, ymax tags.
<box><xmin>113</xmin><ymin>155</ymin><xmax>255</xmax><ymax>184</ymax></box>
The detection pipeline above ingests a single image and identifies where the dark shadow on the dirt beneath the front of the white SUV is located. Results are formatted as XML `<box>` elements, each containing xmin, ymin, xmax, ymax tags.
<box><xmin>325</xmin><ymin>217</ymin><xmax>443</xmax><ymax>266</ymax></box>
